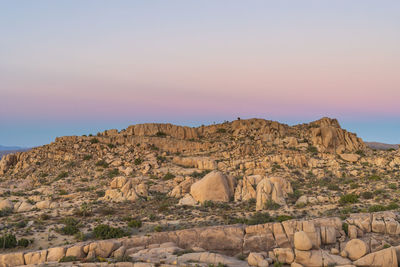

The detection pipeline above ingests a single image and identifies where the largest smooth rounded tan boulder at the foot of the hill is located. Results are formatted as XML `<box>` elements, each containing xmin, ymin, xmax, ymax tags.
<box><xmin>190</xmin><ymin>171</ymin><xmax>233</xmax><ymax>203</ymax></box>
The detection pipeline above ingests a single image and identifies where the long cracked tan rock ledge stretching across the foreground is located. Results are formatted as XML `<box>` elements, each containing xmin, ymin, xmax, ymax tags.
<box><xmin>0</xmin><ymin>212</ymin><xmax>400</xmax><ymax>267</ymax></box>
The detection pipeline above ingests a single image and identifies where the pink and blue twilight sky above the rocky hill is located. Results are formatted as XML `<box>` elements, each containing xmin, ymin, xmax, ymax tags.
<box><xmin>0</xmin><ymin>0</ymin><xmax>400</xmax><ymax>147</ymax></box>
